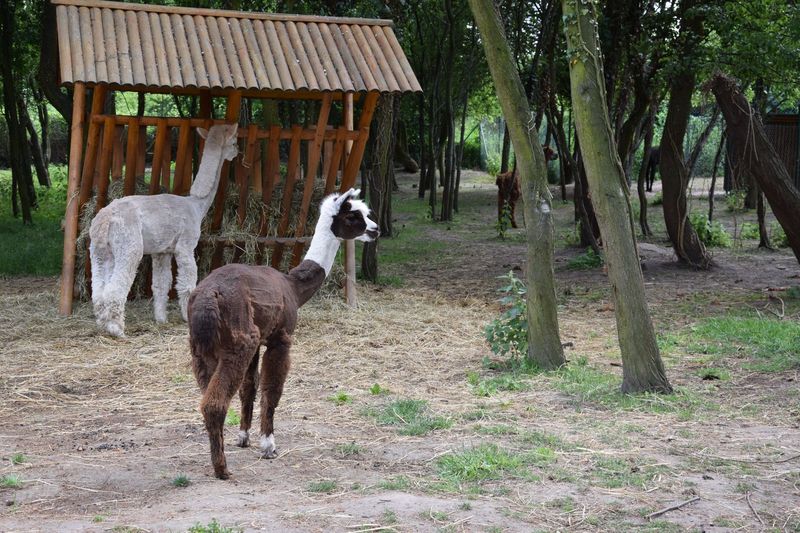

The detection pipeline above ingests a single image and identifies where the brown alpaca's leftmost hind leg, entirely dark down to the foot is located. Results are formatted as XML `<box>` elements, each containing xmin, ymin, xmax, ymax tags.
<box><xmin>200</xmin><ymin>346</ymin><xmax>255</xmax><ymax>479</ymax></box>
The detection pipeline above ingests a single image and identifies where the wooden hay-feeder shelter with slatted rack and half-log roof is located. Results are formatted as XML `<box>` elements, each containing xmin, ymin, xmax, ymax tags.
<box><xmin>53</xmin><ymin>0</ymin><xmax>421</xmax><ymax>314</ymax></box>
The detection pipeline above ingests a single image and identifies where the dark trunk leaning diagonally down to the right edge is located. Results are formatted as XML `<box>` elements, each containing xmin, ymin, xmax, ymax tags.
<box><xmin>708</xmin><ymin>74</ymin><xmax>800</xmax><ymax>261</ymax></box>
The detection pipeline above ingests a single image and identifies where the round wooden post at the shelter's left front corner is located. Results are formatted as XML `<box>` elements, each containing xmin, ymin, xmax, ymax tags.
<box><xmin>58</xmin><ymin>82</ymin><xmax>86</xmax><ymax>315</ymax></box>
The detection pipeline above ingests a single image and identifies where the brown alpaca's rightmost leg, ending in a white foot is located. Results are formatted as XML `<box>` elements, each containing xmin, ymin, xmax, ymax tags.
<box><xmin>260</xmin><ymin>332</ymin><xmax>292</xmax><ymax>459</ymax></box>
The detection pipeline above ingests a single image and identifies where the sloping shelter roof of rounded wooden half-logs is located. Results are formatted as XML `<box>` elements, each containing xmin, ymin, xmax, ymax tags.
<box><xmin>53</xmin><ymin>0</ymin><xmax>421</xmax><ymax>93</ymax></box>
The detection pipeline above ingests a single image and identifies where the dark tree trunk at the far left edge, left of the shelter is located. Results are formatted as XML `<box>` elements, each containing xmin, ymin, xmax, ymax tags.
<box><xmin>0</xmin><ymin>0</ymin><xmax>36</xmax><ymax>224</ymax></box>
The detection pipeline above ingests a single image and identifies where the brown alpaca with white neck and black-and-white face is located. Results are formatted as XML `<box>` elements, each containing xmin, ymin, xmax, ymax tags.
<box><xmin>189</xmin><ymin>189</ymin><xmax>378</xmax><ymax>479</ymax></box>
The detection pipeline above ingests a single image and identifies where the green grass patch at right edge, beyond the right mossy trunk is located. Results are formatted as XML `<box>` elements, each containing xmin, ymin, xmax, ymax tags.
<box><xmin>688</xmin><ymin>316</ymin><xmax>800</xmax><ymax>372</ymax></box>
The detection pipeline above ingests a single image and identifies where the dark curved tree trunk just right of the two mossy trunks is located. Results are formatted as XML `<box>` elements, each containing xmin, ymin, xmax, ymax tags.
<box><xmin>660</xmin><ymin>69</ymin><xmax>712</xmax><ymax>269</ymax></box>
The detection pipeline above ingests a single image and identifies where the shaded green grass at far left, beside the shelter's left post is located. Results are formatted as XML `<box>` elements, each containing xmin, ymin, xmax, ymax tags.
<box><xmin>0</xmin><ymin>166</ymin><xmax>67</xmax><ymax>276</ymax></box>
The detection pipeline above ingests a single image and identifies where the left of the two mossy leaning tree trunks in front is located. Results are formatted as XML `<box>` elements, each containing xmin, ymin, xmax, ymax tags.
<box><xmin>469</xmin><ymin>0</ymin><xmax>565</xmax><ymax>369</ymax></box>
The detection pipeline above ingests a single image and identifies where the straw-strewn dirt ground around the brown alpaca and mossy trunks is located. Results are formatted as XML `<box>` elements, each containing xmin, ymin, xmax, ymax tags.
<box><xmin>0</xmin><ymin>172</ymin><xmax>800</xmax><ymax>532</ymax></box>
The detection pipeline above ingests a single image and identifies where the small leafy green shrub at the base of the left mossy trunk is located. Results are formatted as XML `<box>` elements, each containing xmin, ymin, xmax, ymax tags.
<box><xmin>483</xmin><ymin>271</ymin><xmax>528</xmax><ymax>359</ymax></box>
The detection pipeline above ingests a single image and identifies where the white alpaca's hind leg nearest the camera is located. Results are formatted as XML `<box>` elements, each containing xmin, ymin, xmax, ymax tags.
<box><xmin>105</xmin><ymin>233</ymin><xmax>143</xmax><ymax>337</ymax></box>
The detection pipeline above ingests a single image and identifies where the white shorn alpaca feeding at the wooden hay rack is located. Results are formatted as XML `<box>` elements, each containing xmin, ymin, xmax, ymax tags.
<box><xmin>89</xmin><ymin>124</ymin><xmax>238</xmax><ymax>337</ymax></box>
